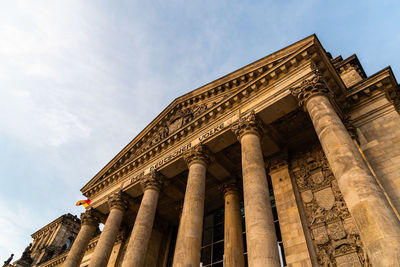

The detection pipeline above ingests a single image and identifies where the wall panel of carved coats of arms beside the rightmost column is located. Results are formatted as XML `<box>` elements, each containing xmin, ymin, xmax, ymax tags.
<box><xmin>290</xmin><ymin>146</ymin><xmax>371</xmax><ymax>267</ymax></box>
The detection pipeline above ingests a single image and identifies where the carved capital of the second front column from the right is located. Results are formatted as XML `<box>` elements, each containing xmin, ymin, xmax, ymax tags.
<box><xmin>231</xmin><ymin>110</ymin><xmax>263</xmax><ymax>141</ymax></box>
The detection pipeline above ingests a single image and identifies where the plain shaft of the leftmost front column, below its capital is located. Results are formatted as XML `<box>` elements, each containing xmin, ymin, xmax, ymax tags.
<box><xmin>63</xmin><ymin>224</ymin><xmax>97</xmax><ymax>267</ymax></box>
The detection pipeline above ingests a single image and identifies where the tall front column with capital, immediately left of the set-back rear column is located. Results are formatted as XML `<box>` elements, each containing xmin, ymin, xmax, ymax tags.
<box><xmin>173</xmin><ymin>145</ymin><xmax>208</xmax><ymax>267</ymax></box>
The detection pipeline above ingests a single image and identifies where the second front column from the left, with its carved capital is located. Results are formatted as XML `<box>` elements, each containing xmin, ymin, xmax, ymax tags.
<box><xmin>89</xmin><ymin>191</ymin><xmax>128</xmax><ymax>267</ymax></box>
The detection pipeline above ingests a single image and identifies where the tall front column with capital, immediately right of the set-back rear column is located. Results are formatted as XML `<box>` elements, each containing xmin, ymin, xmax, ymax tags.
<box><xmin>232</xmin><ymin>112</ymin><xmax>280</xmax><ymax>267</ymax></box>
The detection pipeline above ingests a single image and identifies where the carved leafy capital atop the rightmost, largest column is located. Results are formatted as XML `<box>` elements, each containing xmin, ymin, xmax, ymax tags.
<box><xmin>290</xmin><ymin>71</ymin><xmax>331</xmax><ymax>109</ymax></box>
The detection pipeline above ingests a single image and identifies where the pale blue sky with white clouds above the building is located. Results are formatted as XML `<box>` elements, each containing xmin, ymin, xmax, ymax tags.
<box><xmin>0</xmin><ymin>0</ymin><xmax>400</xmax><ymax>262</ymax></box>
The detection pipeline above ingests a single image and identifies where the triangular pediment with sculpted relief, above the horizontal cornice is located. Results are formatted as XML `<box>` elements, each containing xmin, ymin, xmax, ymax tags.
<box><xmin>81</xmin><ymin>35</ymin><xmax>319</xmax><ymax>193</ymax></box>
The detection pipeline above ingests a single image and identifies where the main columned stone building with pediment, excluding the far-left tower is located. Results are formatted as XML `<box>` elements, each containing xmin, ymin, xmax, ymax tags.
<box><xmin>12</xmin><ymin>35</ymin><xmax>400</xmax><ymax>267</ymax></box>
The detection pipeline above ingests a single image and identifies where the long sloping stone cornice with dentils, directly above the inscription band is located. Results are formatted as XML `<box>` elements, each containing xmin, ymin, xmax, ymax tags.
<box><xmin>82</xmin><ymin>35</ymin><xmax>332</xmax><ymax>200</ymax></box>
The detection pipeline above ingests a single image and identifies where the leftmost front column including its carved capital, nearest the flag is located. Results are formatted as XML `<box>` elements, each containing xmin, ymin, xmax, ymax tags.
<box><xmin>63</xmin><ymin>208</ymin><xmax>100</xmax><ymax>267</ymax></box>
